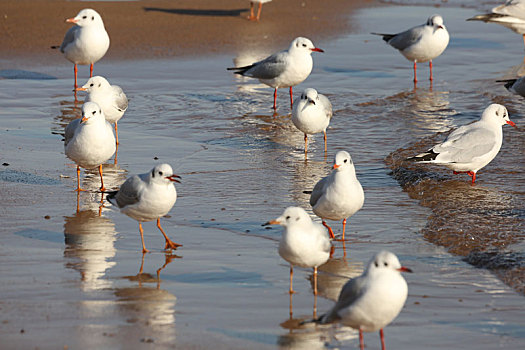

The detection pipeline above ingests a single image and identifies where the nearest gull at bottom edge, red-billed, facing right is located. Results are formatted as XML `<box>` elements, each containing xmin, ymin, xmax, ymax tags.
<box><xmin>317</xmin><ymin>250</ymin><xmax>412</xmax><ymax>350</ymax></box>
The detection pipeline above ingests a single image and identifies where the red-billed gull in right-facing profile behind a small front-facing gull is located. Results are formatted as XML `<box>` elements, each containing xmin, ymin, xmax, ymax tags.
<box><xmin>227</xmin><ymin>37</ymin><xmax>324</xmax><ymax>110</ymax></box>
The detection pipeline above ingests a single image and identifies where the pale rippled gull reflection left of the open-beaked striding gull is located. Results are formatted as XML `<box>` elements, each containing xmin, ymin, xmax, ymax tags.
<box><xmin>64</xmin><ymin>209</ymin><xmax>117</xmax><ymax>291</ymax></box>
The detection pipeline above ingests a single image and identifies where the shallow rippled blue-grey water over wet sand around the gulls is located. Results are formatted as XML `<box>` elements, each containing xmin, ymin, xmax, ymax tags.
<box><xmin>0</xmin><ymin>2</ymin><xmax>525</xmax><ymax>349</ymax></box>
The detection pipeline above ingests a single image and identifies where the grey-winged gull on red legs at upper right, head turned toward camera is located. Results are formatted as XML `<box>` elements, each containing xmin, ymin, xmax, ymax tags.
<box><xmin>372</xmin><ymin>15</ymin><xmax>449</xmax><ymax>83</ymax></box>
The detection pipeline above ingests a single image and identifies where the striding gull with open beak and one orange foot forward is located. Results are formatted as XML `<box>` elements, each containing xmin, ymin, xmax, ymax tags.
<box><xmin>106</xmin><ymin>164</ymin><xmax>182</xmax><ymax>253</ymax></box>
